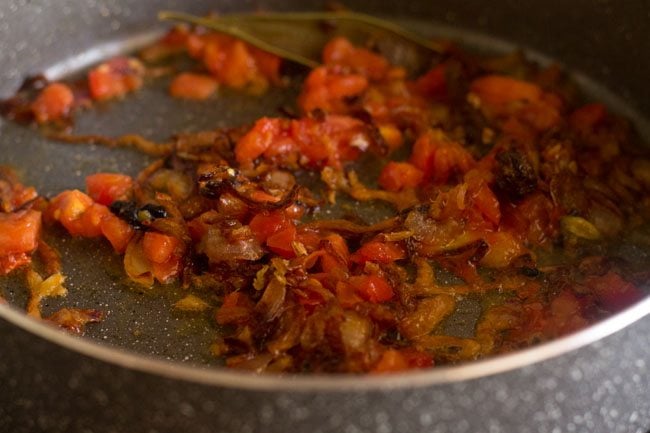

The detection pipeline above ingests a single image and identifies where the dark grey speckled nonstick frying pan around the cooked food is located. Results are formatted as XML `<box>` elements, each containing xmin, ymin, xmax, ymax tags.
<box><xmin>0</xmin><ymin>0</ymin><xmax>650</xmax><ymax>433</ymax></box>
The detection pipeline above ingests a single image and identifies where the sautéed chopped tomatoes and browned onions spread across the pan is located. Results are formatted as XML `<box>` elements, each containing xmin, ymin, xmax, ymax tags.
<box><xmin>0</xmin><ymin>19</ymin><xmax>650</xmax><ymax>373</ymax></box>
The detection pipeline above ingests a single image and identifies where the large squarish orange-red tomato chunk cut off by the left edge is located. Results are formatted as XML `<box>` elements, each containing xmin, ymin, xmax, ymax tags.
<box><xmin>0</xmin><ymin>209</ymin><xmax>41</xmax><ymax>256</ymax></box>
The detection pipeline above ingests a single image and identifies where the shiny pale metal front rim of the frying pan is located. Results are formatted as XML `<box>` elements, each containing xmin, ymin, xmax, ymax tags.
<box><xmin>0</xmin><ymin>296</ymin><xmax>650</xmax><ymax>392</ymax></box>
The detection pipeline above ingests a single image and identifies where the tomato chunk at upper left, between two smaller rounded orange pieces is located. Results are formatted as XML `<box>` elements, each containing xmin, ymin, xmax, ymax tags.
<box><xmin>88</xmin><ymin>57</ymin><xmax>144</xmax><ymax>101</ymax></box>
